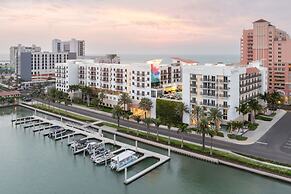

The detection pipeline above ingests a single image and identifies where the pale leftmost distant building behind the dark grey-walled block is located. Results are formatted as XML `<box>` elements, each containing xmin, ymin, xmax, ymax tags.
<box><xmin>10</xmin><ymin>44</ymin><xmax>41</xmax><ymax>75</ymax></box>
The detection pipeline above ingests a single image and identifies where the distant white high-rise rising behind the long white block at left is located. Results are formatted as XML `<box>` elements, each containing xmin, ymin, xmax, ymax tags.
<box><xmin>52</xmin><ymin>39</ymin><xmax>85</xmax><ymax>57</ymax></box>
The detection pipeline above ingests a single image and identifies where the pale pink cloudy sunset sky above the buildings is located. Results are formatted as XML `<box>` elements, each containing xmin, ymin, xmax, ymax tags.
<box><xmin>0</xmin><ymin>0</ymin><xmax>291</xmax><ymax>55</ymax></box>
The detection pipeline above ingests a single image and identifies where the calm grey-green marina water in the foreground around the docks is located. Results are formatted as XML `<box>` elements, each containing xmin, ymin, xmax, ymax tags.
<box><xmin>0</xmin><ymin>107</ymin><xmax>291</xmax><ymax>194</ymax></box>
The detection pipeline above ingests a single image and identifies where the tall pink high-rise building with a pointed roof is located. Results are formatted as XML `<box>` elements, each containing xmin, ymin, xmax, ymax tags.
<box><xmin>240</xmin><ymin>19</ymin><xmax>291</xmax><ymax>103</ymax></box>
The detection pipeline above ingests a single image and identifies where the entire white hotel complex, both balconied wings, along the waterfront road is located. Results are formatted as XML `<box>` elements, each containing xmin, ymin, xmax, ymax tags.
<box><xmin>55</xmin><ymin>59</ymin><xmax>267</xmax><ymax>124</ymax></box>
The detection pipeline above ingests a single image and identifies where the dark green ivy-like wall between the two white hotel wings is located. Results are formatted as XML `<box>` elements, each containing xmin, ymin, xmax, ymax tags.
<box><xmin>156</xmin><ymin>99</ymin><xmax>183</xmax><ymax>125</ymax></box>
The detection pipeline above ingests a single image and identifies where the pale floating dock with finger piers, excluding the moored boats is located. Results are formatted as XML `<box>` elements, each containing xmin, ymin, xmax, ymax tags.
<box><xmin>12</xmin><ymin>116</ymin><xmax>170</xmax><ymax>184</ymax></box>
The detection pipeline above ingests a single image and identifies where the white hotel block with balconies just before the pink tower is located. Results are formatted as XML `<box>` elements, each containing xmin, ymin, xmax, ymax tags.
<box><xmin>182</xmin><ymin>62</ymin><xmax>267</xmax><ymax>124</ymax></box>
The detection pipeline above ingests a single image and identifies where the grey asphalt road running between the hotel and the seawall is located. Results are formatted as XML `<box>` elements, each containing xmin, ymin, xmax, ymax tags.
<box><xmin>38</xmin><ymin>99</ymin><xmax>291</xmax><ymax>165</ymax></box>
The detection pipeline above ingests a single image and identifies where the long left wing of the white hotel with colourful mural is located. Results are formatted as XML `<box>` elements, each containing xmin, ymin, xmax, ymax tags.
<box><xmin>55</xmin><ymin>59</ymin><xmax>190</xmax><ymax>112</ymax></box>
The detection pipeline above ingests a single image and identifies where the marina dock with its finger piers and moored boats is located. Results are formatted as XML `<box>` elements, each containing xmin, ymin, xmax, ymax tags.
<box><xmin>11</xmin><ymin>115</ymin><xmax>170</xmax><ymax>184</ymax></box>
